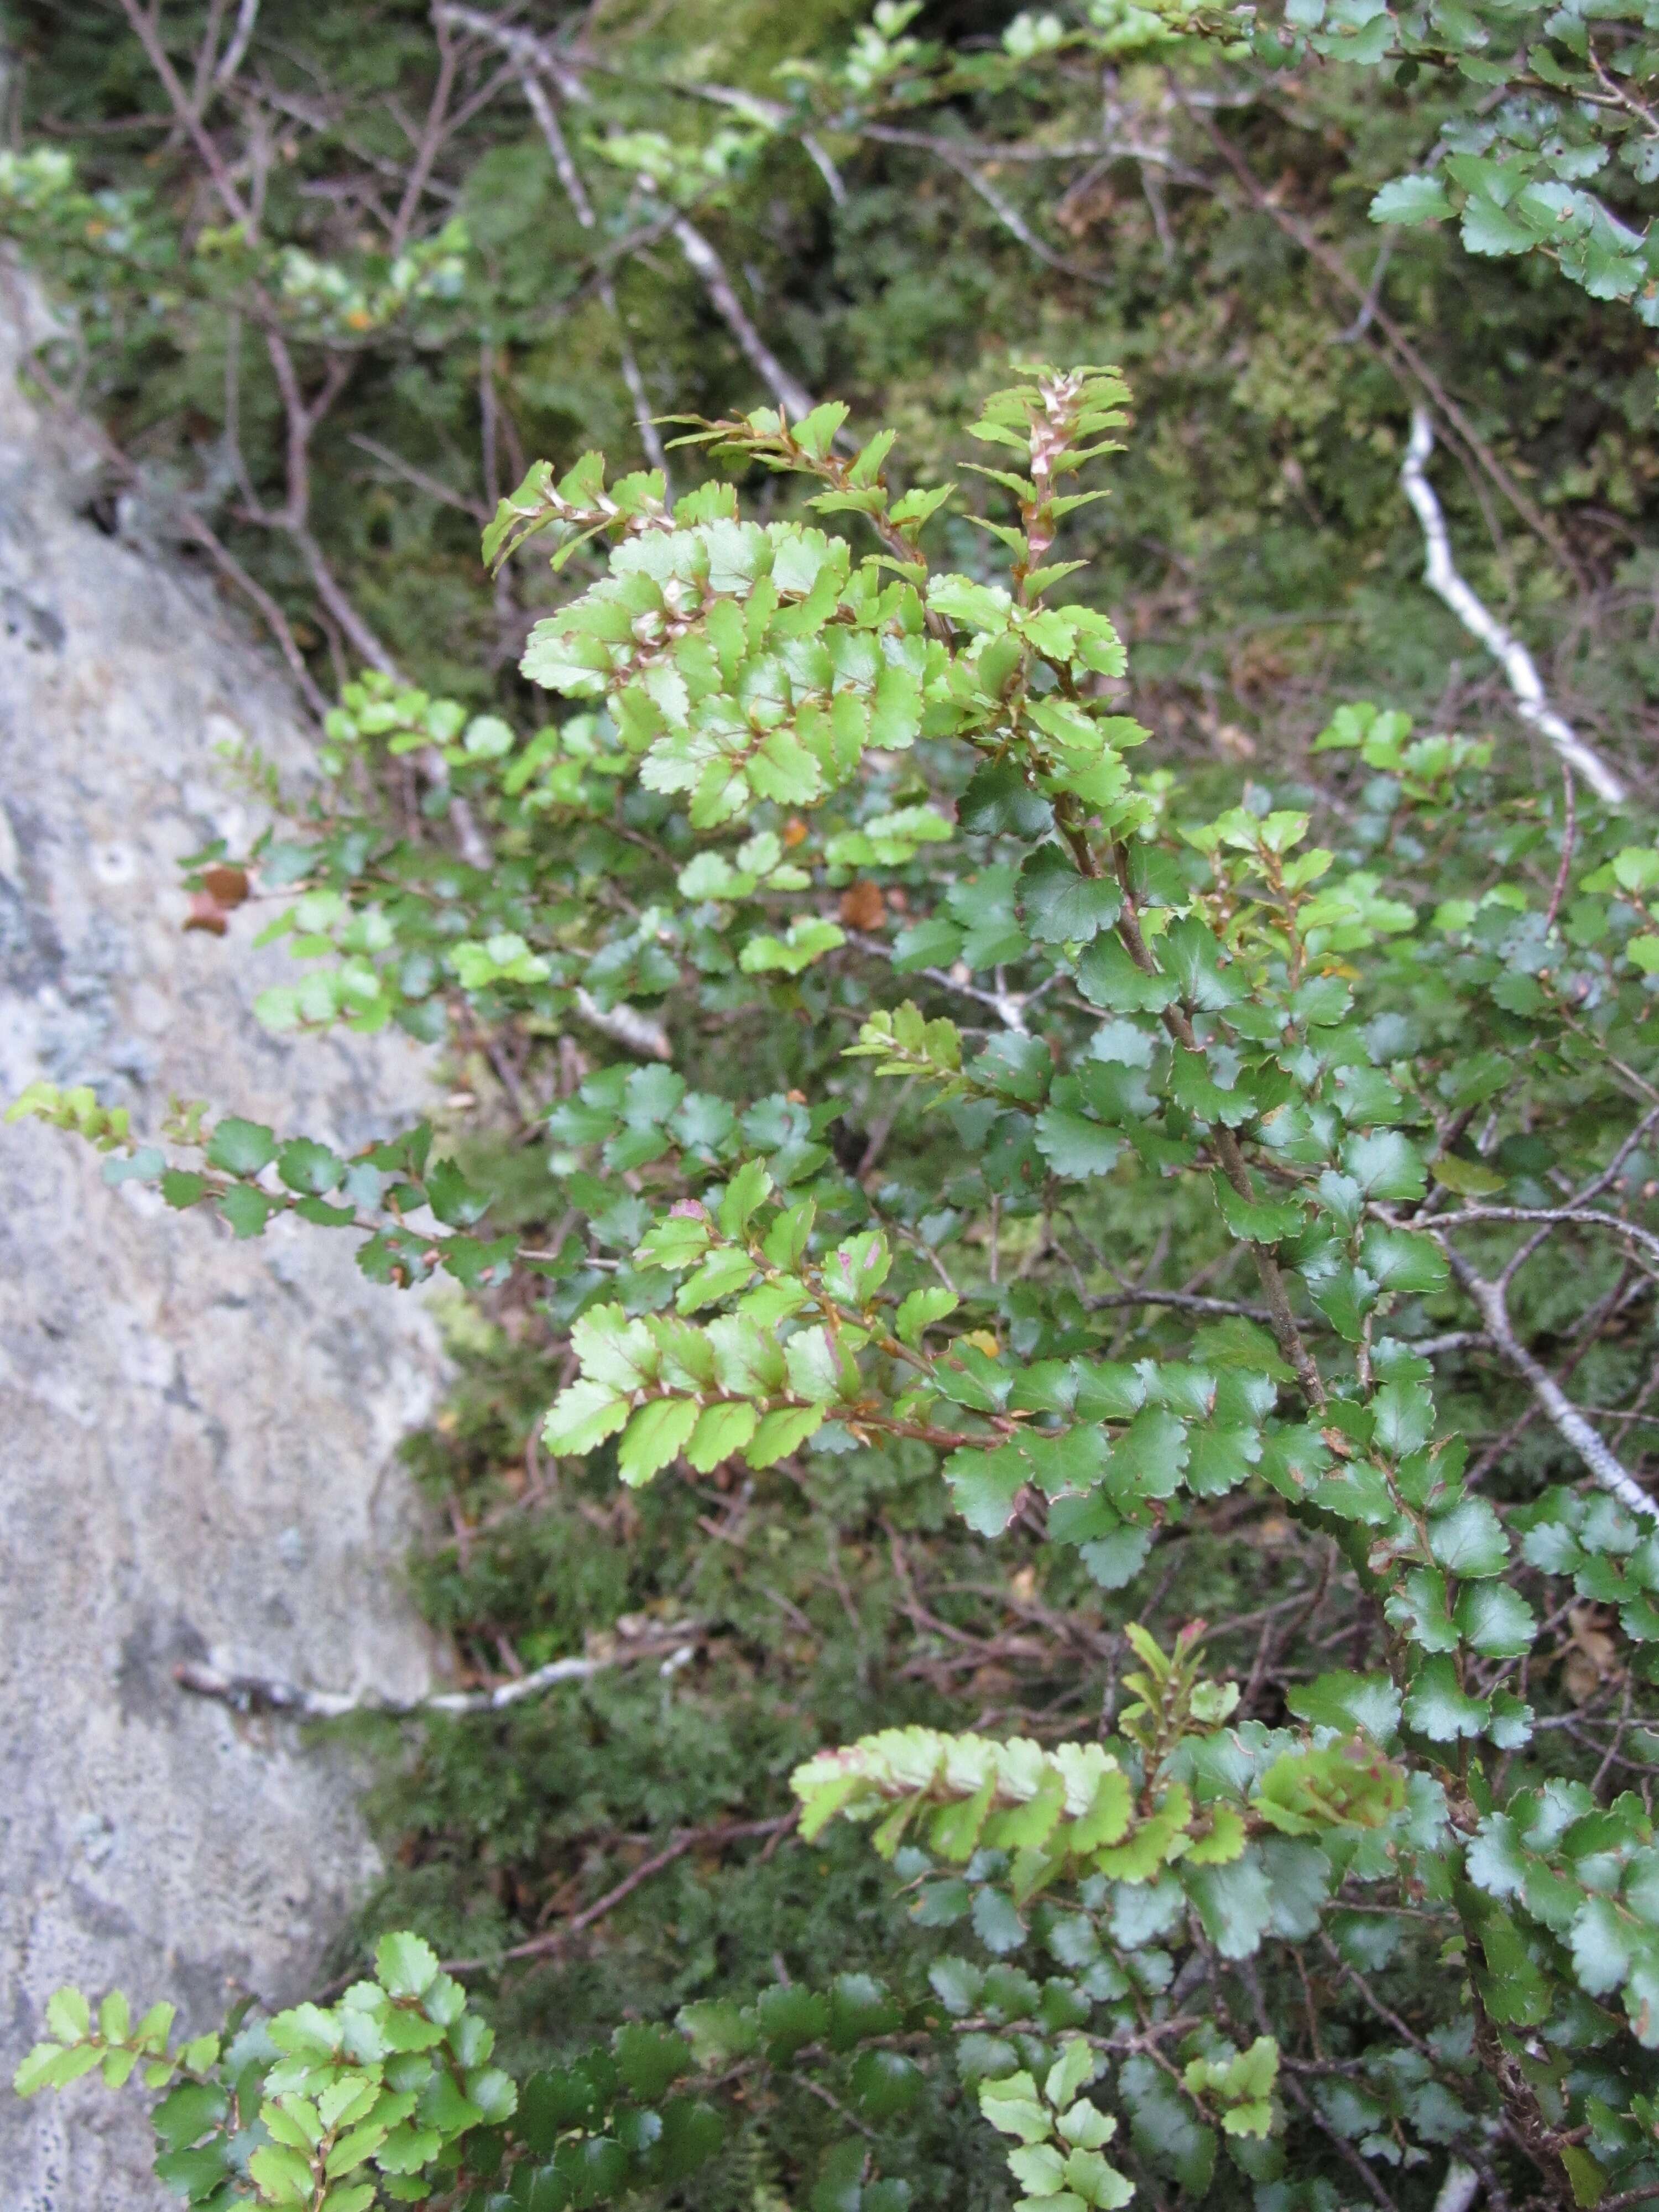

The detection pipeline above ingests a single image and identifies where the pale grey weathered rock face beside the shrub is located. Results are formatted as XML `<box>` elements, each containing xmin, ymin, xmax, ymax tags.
<box><xmin>0</xmin><ymin>272</ymin><xmax>440</xmax><ymax>2212</ymax></box>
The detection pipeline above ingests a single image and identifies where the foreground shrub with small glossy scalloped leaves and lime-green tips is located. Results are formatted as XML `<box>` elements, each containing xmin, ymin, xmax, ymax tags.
<box><xmin>13</xmin><ymin>354</ymin><xmax>1659</xmax><ymax>2212</ymax></box>
